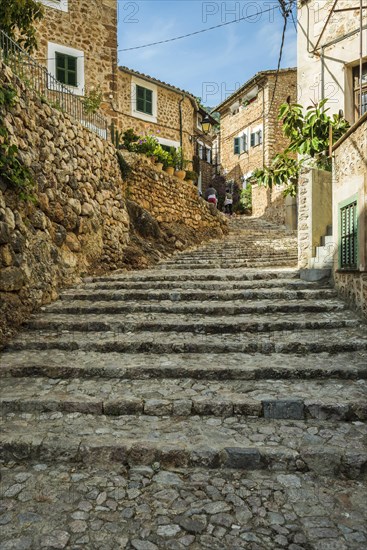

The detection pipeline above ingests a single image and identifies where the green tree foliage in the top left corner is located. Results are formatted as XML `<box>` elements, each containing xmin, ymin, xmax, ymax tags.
<box><xmin>0</xmin><ymin>0</ymin><xmax>44</xmax><ymax>52</ymax></box>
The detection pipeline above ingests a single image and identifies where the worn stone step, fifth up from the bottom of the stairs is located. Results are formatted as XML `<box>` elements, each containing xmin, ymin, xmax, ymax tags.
<box><xmin>24</xmin><ymin>311</ymin><xmax>361</xmax><ymax>334</ymax></box>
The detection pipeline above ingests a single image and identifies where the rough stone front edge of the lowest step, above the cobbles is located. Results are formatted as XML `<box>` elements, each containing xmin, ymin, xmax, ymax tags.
<box><xmin>0</xmin><ymin>435</ymin><xmax>367</xmax><ymax>479</ymax></box>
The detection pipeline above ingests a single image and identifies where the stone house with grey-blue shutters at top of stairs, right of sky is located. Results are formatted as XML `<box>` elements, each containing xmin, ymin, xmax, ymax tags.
<box><xmin>214</xmin><ymin>68</ymin><xmax>297</xmax><ymax>223</ymax></box>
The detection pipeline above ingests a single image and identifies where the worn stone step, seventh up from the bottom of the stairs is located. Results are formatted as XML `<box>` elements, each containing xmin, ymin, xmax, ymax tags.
<box><xmin>60</xmin><ymin>286</ymin><xmax>336</xmax><ymax>302</ymax></box>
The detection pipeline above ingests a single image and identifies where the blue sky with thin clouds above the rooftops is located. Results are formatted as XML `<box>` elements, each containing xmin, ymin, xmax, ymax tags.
<box><xmin>118</xmin><ymin>0</ymin><xmax>296</xmax><ymax>107</ymax></box>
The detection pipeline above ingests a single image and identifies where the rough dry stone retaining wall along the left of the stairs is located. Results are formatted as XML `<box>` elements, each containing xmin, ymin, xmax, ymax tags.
<box><xmin>0</xmin><ymin>65</ymin><xmax>225</xmax><ymax>346</ymax></box>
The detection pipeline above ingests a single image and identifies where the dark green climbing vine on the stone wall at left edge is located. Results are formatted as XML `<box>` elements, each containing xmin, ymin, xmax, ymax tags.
<box><xmin>0</xmin><ymin>84</ymin><xmax>34</xmax><ymax>201</ymax></box>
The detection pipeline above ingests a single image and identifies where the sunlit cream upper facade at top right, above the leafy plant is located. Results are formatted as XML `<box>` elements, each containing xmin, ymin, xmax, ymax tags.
<box><xmin>297</xmin><ymin>0</ymin><xmax>367</xmax><ymax>124</ymax></box>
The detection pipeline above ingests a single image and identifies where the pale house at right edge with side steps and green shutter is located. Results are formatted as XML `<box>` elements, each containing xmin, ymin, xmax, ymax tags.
<box><xmin>298</xmin><ymin>0</ymin><xmax>367</xmax><ymax>314</ymax></box>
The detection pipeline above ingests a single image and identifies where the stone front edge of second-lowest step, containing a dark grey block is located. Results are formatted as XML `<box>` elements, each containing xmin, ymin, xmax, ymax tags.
<box><xmin>0</xmin><ymin>396</ymin><xmax>367</xmax><ymax>422</ymax></box>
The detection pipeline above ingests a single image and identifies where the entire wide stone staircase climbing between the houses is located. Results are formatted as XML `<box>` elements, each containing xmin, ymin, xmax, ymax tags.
<box><xmin>0</xmin><ymin>218</ymin><xmax>367</xmax><ymax>550</ymax></box>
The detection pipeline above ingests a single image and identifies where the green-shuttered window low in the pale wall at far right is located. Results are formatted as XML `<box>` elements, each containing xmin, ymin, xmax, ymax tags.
<box><xmin>339</xmin><ymin>199</ymin><xmax>358</xmax><ymax>269</ymax></box>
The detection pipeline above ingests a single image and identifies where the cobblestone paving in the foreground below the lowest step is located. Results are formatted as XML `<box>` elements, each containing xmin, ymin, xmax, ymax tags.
<box><xmin>0</xmin><ymin>461</ymin><xmax>367</xmax><ymax>550</ymax></box>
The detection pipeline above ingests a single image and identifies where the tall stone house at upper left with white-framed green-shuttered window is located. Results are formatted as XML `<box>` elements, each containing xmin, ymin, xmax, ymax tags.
<box><xmin>33</xmin><ymin>0</ymin><xmax>117</xmax><ymax>119</ymax></box>
